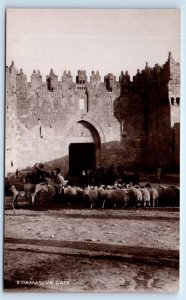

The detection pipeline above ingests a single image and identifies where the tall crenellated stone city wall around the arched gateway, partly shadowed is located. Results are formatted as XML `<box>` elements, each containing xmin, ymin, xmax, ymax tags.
<box><xmin>6</xmin><ymin>54</ymin><xmax>179</xmax><ymax>174</ymax></box>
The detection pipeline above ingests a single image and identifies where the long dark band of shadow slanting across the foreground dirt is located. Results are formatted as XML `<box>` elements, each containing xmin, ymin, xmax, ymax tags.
<box><xmin>4</xmin><ymin>238</ymin><xmax>179</xmax><ymax>267</ymax></box>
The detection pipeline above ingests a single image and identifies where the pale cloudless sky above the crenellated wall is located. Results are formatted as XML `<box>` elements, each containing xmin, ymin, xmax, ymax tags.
<box><xmin>6</xmin><ymin>9</ymin><xmax>180</xmax><ymax>81</ymax></box>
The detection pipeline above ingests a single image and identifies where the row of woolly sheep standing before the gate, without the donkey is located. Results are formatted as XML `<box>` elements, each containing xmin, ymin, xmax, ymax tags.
<box><xmin>54</xmin><ymin>184</ymin><xmax>180</xmax><ymax>208</ymax></box>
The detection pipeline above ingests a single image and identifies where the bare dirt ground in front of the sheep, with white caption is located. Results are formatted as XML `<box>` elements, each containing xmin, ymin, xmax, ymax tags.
<box><xmin>4</xmin><ymin>208</ymin><xmax>179</xmax><ymax>292</ymax></box>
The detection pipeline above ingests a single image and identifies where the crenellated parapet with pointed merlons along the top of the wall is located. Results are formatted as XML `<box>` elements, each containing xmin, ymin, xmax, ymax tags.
<box><xmin>6</xmin><ymin>52</ymin><xmax>180</xmax><ymax>104</ymax></box>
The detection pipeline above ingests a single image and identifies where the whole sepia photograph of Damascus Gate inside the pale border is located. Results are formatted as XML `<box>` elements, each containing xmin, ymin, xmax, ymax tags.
<box><xmin>4</xmin><ymin>8</ymin><xmax>180</xmax><ymax>293</ymax></box>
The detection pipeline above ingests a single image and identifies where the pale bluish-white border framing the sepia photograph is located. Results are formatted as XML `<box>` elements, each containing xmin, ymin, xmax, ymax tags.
<box><xmin>0</xmin><ymin>0</ymin><xmax>186</xmax><ymax>300</ymax></box>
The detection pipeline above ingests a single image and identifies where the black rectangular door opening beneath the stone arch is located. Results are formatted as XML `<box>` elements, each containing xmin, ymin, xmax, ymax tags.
<box><xmin>69</xmin><ymin>143</ymin><xmax>95</xmax><ymax>176</ymax></box>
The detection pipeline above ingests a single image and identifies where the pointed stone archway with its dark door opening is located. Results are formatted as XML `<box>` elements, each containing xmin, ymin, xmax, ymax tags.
<box><xmin>63</xmin><ymin>115</ymin><xmax>105</xmax><ymax>176</ymax></box>
